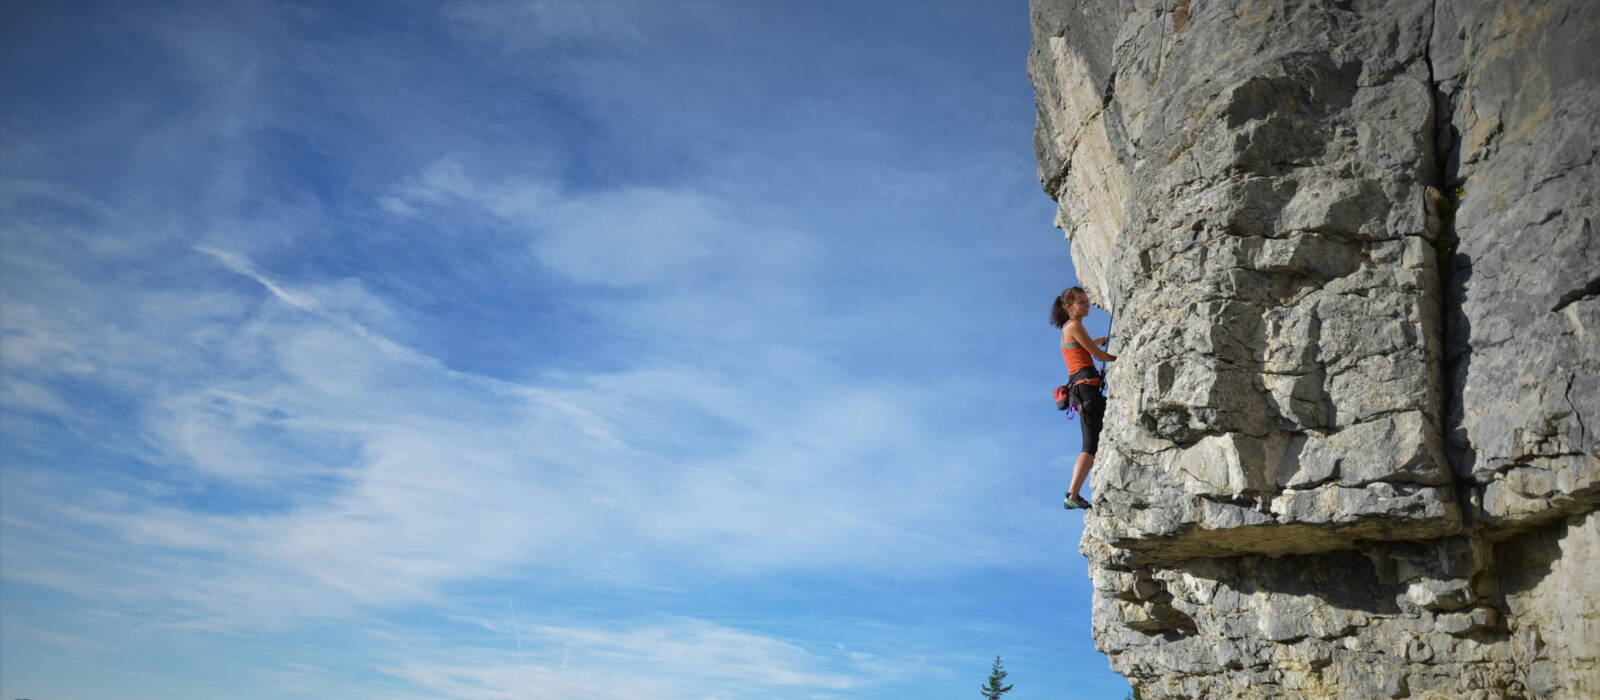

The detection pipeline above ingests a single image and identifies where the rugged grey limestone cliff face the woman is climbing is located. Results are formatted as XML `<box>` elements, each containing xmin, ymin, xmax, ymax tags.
<box><xmin>1029</xmin><ymin>0</ymin><xmax>1600</xmax><ymax>698</ymax></box>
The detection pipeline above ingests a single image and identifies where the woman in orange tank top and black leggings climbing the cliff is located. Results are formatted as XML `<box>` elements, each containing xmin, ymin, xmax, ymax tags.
<box><xmin>1050</xmin><ymin>286</ymin><xmax>1117</xmax><ymax>510</ymax></box>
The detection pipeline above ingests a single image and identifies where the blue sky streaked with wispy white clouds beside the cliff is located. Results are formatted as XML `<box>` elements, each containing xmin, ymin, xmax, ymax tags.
<box><xmin>0</xmin><ymin>0</ymin><xmax>1128</xmax><ymax>700</ymax></box>
